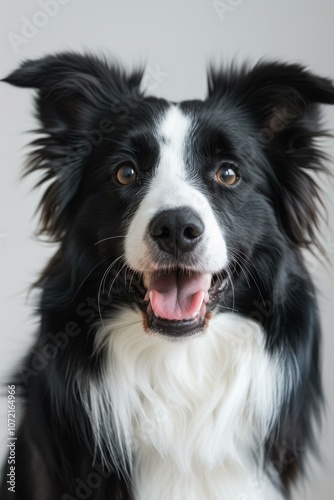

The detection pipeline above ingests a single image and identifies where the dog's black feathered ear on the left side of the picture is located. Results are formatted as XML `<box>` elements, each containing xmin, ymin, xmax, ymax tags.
<box><xmin>3</xmin><ymin>53</ymin><xmax>142</xmax><ymax>240</ymax></box>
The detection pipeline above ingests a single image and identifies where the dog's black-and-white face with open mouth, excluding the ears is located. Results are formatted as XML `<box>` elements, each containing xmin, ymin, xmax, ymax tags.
<box><xmin>87</xmin><ymin>100</ymin><xmax>277</xmax><ymax>338</ymax></box>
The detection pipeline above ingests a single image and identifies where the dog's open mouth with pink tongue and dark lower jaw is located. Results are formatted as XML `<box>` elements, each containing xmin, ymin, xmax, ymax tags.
<box><xmin>134</xmin><ymin>268</ymin><xmax>228</xmax><ymax>338</ymax></box>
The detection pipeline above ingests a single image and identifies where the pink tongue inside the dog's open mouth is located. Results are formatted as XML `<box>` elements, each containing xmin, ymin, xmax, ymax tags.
<box><xmin>146</xmin><ymin>272</ymin><xmax>207</xmax><ymax>321</ymax></box>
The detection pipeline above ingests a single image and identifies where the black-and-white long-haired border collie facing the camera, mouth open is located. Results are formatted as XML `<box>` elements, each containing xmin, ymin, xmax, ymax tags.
<box><xmin>1</xmin><ymin>52</ymin><xmax>334</xmax><ymax>500</ymax></box>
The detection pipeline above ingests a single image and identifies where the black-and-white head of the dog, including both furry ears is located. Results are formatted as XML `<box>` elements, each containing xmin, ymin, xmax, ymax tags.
<box><xmin>5</xmin><ymin>53</ymin><xmax>334</xmax><ymax>337</ymax></box>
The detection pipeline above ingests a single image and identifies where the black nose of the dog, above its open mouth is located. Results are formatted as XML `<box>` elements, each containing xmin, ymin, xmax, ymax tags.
<box><xmin>149</xmin><ymin>207</ymin><xmax>204</xmax><ymax>256</ymax></box>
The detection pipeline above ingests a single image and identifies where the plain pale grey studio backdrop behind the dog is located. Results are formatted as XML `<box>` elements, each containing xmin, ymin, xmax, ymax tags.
<box><xmin>0</xmin><ymin>0</ymin><xmax>334</xmax><ymax>500</ymax></box>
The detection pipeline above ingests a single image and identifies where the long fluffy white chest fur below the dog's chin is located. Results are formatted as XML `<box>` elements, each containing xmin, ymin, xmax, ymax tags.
<box><xmin>87</xmin><ymin>311</ymin><xmax>282</xmax><ymax>500</ymax></box>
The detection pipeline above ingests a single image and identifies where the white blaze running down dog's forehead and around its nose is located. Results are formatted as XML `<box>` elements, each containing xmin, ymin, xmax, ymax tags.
<box><xmin>125</xmin><ymin>105</ymin><xmax>227</xmax><ymax>272</ymax></box>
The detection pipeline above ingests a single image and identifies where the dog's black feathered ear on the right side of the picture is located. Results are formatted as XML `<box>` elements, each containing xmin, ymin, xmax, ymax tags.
<box><xmin>209</xmin><ymin>62</ymin><xmax>334</xmax><ymax>247</ymax></box>
